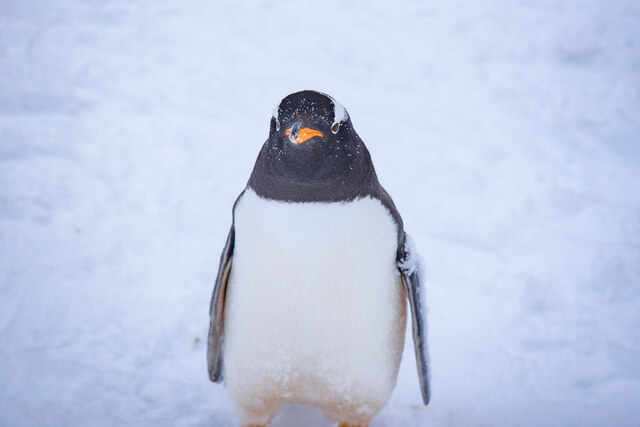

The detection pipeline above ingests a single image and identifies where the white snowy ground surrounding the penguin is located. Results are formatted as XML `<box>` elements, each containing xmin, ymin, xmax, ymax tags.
<box><xmin>0</xmin><ymin>0</ymin><xmax>640</xmax><ymax>427</ymax></box>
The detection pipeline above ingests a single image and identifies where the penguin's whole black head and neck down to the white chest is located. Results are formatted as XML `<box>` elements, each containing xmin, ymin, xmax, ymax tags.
<box><xmin>249</xmin><ymin>90</ymin><xmax>379</xmax><ymax>202</ymax></box>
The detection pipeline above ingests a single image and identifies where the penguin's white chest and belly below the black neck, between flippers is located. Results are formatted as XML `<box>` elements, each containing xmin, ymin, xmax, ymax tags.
<box><xmin>224</xmin><ymin>189</ymin><xmax>406</xmax><ymax>422</ymax></box>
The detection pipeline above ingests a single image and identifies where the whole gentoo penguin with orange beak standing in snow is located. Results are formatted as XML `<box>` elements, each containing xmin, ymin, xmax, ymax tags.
<box><xmin>207</xmin><ymin>91</ymin><xmax>430</xmax><ymax>426</ymax></box>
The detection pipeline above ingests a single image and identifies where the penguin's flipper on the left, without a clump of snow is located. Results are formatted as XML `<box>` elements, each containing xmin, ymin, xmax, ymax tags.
<box><xmin>207</xmin><ymin>225</ymin><xmax>235</xmax><ymax>383</ymax></box>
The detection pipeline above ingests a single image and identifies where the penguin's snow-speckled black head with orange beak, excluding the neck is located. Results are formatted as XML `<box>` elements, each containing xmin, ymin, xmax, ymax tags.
<box><xmin>267</xmin><ymin>90</ymin><xmax>361</xmax><ymax>179</ymax></box>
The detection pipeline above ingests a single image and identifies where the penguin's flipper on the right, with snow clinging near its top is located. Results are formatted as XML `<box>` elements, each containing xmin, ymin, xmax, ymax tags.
<box><xmin>398</xmin><ymin>233</ymin><xmax>431</xmax><ymax>405</ymax></box>
